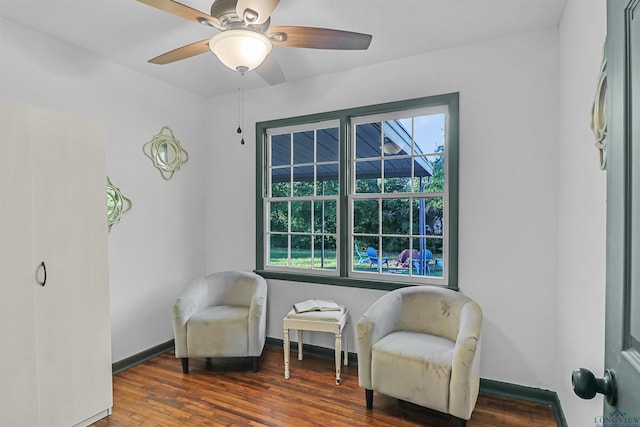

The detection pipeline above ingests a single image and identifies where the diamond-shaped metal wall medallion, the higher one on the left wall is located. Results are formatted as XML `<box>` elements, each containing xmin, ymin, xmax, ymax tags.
<box><xmin>142</xmin><ymin>126</ymin><xmax>189</xmax><ymax>180</ymax></box>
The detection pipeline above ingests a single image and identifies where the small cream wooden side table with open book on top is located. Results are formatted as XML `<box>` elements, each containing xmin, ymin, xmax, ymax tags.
<box><xmin>282</xmin><ymin>307</ymin><xmax>349</xmax><ymax>385</ymax></box>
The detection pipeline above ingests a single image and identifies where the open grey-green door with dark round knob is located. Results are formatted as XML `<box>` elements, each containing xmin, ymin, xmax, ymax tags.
<box><xmin>573</xmin><ymin>0</ymin><xmax>640</xmax><ymax>427</ymax></box>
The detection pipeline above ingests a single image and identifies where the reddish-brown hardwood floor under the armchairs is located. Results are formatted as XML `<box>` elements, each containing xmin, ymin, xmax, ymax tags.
<box><xmin>93</xmin><ymin>347</ymin><xmax>556</xmax><ymax>427</ymax></box>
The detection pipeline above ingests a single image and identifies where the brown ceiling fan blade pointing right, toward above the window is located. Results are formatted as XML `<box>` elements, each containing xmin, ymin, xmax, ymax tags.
<box><xmin>267</xmin><ymin>26</ymin><xmax>372</xmax><ymax>50</ymax></box>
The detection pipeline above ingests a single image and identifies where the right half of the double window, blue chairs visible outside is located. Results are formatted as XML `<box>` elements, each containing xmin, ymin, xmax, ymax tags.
<box><xmin>349</xmin><ymin>107</ymin><xmax>448</xmax><ymax>281</ymax></box>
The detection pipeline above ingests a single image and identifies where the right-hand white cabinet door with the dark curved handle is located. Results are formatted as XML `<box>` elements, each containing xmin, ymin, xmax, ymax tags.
<box><xmin>31</xmin><ymin>109</ymin><xmax>112</xmax><ymax>426</ymax></box>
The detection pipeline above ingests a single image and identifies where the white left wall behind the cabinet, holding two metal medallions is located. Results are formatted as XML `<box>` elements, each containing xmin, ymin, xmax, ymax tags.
<box><xmin>0</xmin><ymin>20</ymin><xmax>208</xmax><ymax>361</ymax></box>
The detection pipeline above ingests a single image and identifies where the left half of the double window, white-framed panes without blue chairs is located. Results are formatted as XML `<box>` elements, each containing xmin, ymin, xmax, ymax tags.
<box><xmin>265</xmin><ymin>122</ymin><xmax>340</xmax><ymax>272</ymax></box>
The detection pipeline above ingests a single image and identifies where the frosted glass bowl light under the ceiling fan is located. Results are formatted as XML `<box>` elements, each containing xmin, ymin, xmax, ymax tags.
<box><xmin>209</xmin><ymin>29</ymin><xmax>271</xmax><ymax>74</ymax></box>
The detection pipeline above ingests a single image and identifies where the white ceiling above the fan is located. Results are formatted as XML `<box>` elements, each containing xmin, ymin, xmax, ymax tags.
<box><xmin>0</xmin><ymin>0</ymin><xmax>566</xmax><ymax>97</ymax></box>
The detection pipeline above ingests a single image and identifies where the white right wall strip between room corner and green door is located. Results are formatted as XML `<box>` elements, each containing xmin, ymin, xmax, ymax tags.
<box><xmin>555</xmin><ymin>0</ymin><xmax>607</xmax><ymax>426</ymax></box>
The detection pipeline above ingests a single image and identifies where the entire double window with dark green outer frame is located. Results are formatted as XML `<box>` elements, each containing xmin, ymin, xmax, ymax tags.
<box><xmin>256</xmin><ymin>94</ymin><xmax>458</xmax><ymax>289</ymax></box>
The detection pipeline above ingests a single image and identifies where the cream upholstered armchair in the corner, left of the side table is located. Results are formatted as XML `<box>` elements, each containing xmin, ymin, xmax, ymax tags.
<box><xmin>173</xmin><ymin>271</ymin><xmax>267</xmax><ymax>374</ymax></box>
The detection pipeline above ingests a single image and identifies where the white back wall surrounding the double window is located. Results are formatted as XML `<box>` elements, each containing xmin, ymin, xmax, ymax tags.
<box><xmin>207</xmin><ymin>28</ymin><xmax>558</xmax><ymax>389</ymax></box>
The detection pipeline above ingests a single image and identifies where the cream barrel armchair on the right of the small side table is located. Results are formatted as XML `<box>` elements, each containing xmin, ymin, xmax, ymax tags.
<box><xmin>356</xmin><ymin>285</ymin><xmax>482</xmax><ymax>426</ymax></box>
